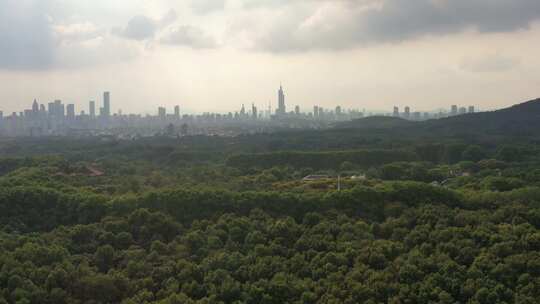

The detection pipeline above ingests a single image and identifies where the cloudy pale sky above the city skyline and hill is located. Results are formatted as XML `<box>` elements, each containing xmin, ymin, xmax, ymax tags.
<box><xmin>0</xmin><ymin>0</ymin><xmax>540</xmax><ymax>114</ymax></box>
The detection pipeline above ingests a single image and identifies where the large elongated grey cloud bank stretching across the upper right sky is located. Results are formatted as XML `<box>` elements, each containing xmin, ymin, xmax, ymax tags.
<box><xmin>246</xmin><ymin>0</ymin><xmax>540</xmax><ymax>52</ymax></box>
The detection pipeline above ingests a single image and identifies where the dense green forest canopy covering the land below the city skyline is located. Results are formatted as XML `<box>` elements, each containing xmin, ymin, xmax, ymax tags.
<box><xmin>0</xmin><ymin>99</ymin><xmax>540</xmax><ymax>304</ymax></box>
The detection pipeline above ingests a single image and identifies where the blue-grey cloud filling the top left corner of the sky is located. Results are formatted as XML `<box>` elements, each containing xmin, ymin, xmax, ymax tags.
<box><xmin>0</xmin><ymin>0</ymin><xmax>56</xmax><ymax>69</ymax></box>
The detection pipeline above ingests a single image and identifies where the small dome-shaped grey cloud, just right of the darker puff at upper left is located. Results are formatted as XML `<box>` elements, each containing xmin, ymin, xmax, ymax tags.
<box><xmin>161</xmin><ymin>25</ymin><xmax>217</xmax><ymax>49</ymax></box>
